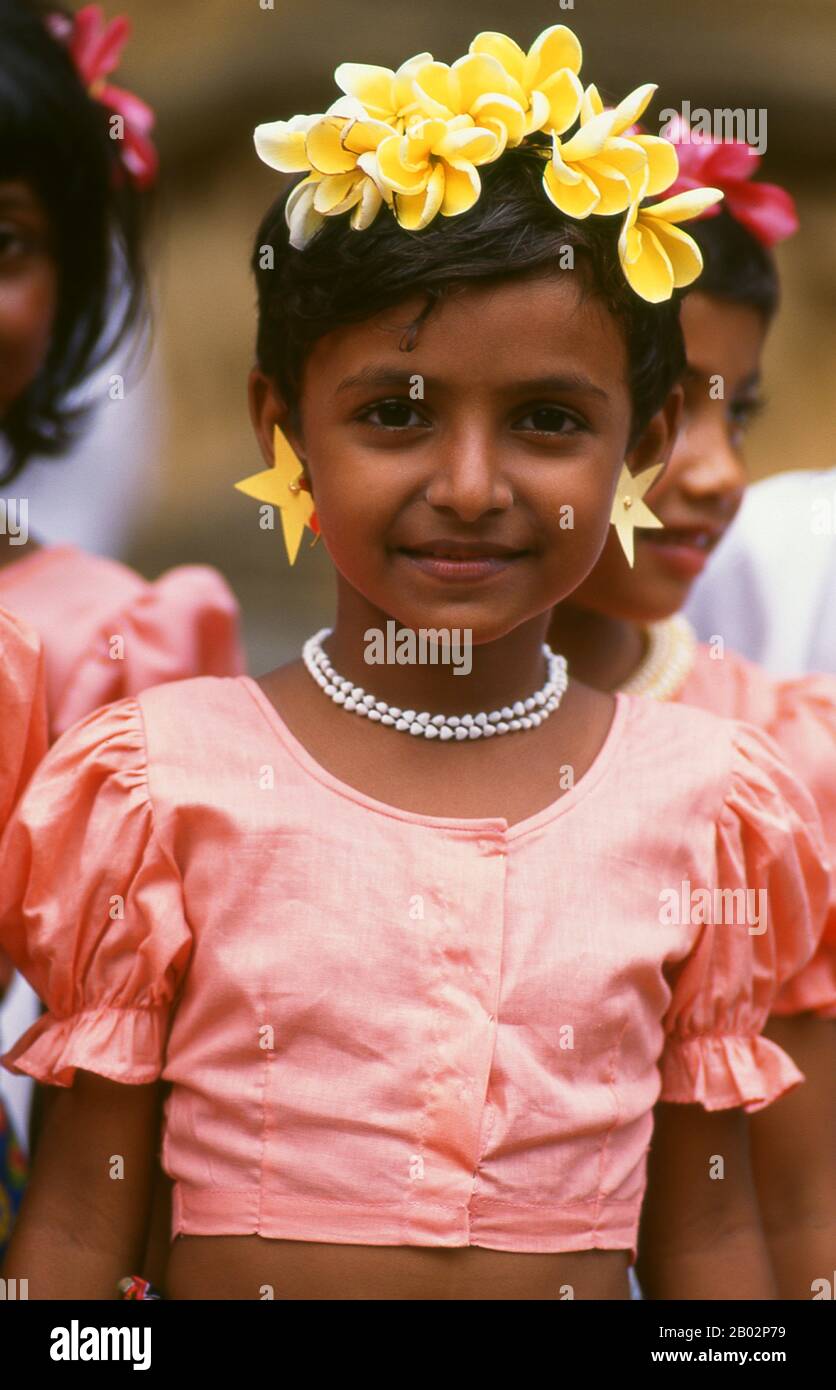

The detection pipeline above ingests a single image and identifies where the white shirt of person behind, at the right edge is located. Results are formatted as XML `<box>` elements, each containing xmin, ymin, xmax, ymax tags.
<box><xmin>684</xmin><ymin>468</ymin><xmax>836</xmax><ymax>676</ymax></box>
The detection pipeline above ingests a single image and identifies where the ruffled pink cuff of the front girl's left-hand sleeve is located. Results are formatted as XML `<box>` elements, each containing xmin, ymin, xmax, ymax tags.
<box><xmin>0</xmin><ymin>1005</ymin><xmax>170</xmax><ymax>1086</ymax></box>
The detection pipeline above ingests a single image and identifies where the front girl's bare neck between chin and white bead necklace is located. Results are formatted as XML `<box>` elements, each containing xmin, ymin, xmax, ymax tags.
<box><xmin>324</xmin><ymin>596</ymin><xmax>549</xmax><ymax>714</ymax></box>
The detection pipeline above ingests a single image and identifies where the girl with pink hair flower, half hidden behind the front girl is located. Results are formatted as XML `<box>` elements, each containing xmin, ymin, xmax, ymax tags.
<box><xmin>551</xmin><ymin>132</ymin><xmax>836</xmax><ymax>1298</ymax></box>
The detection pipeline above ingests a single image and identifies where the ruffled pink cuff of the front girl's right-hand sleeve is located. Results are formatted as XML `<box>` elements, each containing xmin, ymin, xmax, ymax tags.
<box><xmin>659</xmin><ymin>1034</ymin><xmax>804</xmax><ymax>1112</ymax></box>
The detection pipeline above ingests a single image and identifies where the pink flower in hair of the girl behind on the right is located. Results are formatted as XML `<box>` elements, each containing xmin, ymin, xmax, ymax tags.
<box><xmin>662</xmin><ymin>115</ymin><xmax>798</xmax><ymax>246</ymax></box>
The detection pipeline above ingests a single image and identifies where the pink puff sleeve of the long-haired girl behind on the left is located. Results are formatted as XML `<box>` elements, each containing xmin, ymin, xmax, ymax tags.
<box><xmin>53</xmin><ymin>564</ymin><xmax>246</xmax><ymax>734</ymax></box>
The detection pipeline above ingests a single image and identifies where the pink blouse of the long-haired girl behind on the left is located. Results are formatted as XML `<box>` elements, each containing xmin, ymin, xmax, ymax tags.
<box><xmin>0</xmin><ymin>545</ymin><xmax>246</xmax><ymax>738</ymax></box>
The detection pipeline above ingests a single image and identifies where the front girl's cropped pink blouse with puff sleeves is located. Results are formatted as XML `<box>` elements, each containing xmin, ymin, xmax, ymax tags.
<box><xmin>0</xmin><ymin>677</ymin><xmax>828</xmax><ymax>1258</ymax></box>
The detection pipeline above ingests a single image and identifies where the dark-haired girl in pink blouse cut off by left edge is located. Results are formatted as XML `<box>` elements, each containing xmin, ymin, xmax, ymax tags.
<box><xmin>0</xmin><ymin>0</ymin><xmax>243</xmax><ymax>1262</ymax></box>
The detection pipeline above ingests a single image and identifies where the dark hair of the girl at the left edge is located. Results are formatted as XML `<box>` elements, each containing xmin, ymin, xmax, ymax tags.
<box><xmin>0</xmin><ymin>0</ymin><xmax>147</xmax><ymax>481</ymax></box>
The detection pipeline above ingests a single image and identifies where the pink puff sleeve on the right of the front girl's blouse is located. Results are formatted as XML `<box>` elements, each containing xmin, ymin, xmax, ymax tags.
<box><xmin>659</xmin><ymin>723</ymin><xmax>829</xmax><ymax>1111</ymax></box>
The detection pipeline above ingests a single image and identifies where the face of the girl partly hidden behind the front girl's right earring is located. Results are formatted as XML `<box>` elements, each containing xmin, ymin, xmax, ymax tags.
<box><xmin>572</xmin><ymin>292</ymin><xmax>768</xmax><ymax>623</ymax></box>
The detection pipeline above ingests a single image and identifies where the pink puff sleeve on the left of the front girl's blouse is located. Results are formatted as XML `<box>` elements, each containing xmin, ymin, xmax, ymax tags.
<box><xmin>0</xmin><ymin>699</ymin><xmax>192</xmax><ymax>1086</ymax></box>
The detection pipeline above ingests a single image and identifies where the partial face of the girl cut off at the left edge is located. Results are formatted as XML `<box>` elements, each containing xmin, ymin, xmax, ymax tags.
<box><xmin>0</xmin><ymin>181</ymin><xmax>57</xmax><ymax>420</ymax></box>
